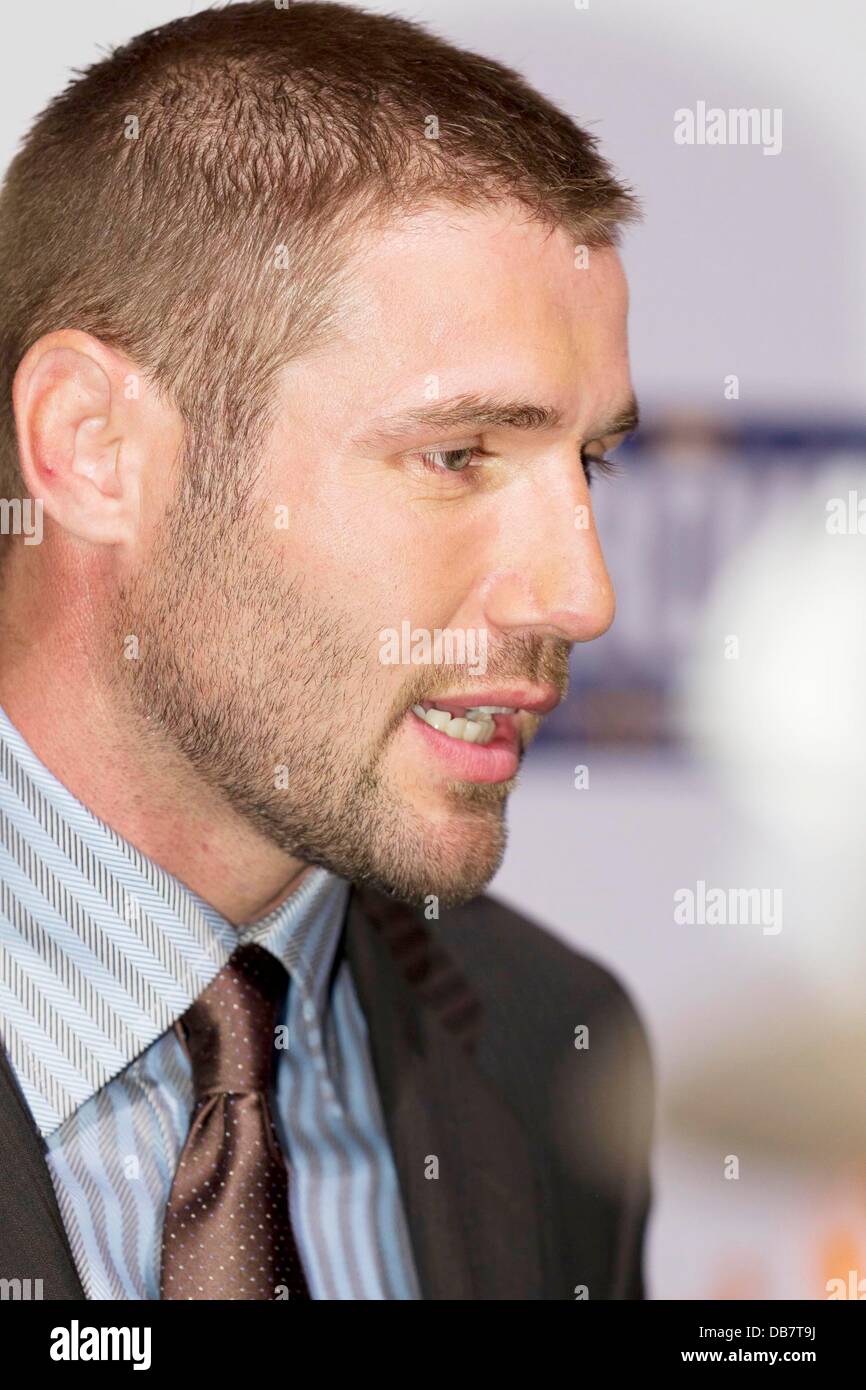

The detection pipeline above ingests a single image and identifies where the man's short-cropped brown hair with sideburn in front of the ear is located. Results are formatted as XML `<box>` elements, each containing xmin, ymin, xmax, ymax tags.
<box><xmin>0</xmin><ymin>0</ymin><xmax>637</xmax><ymax>519</ymax></box>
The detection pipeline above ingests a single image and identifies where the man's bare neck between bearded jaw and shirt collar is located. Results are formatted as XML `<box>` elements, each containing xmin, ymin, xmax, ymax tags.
<box><xmin>0</xmin><ymin>550</ymin><xmax>309</xmax><ymax>926</ymax></box>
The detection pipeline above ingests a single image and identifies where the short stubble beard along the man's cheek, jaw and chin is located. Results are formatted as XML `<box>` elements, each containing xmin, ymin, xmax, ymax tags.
<box><xmin>113</xmin><ymin>498</ymin><xmax>513</xmax><ymax>906</ymax></box>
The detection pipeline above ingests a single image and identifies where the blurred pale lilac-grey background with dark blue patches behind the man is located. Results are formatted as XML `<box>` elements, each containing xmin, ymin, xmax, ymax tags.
<box><xmin>6</xmin><ymin>0</ymin><xmax>866</xmax><ymax>1300</ymax></box>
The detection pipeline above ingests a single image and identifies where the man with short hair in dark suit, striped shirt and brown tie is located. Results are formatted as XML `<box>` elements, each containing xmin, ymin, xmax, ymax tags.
<box><xmin>0</xmin><ymin>3</ymin><xmax>652</xmax><ymax>1301</ymax></box>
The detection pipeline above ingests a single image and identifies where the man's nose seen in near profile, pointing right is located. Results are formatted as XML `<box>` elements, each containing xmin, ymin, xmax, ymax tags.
<box><xmin>482</xmin><ymin>466</ymin><xmax>616</xmax><ymax>642</ymax></box>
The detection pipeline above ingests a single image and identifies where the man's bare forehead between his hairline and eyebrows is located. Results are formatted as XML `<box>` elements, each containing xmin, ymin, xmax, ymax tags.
<box><xmin>284</xmin><ymin>204</ymin><xmax>630</xmax><ymax>425</ymax></box>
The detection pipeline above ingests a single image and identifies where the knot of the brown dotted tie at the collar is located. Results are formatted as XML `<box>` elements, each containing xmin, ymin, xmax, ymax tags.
<box><xmin>181</xmin><ymin>945</ymin><xmax>289</xmax><ymax>1099</ymax></box>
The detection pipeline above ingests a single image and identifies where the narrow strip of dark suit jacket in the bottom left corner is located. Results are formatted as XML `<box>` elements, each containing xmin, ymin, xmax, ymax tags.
<box><xmin>0</xmin><ymin>1047</ymin><xmax>85</xmax><ymax>1300</ymax></box>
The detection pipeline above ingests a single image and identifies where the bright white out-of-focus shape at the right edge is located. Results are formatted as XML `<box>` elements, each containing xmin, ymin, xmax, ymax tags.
<box><xmin>681</xmin><ymin>457</ymin><xmax>866</xmax><ymax>1000</ymax></box>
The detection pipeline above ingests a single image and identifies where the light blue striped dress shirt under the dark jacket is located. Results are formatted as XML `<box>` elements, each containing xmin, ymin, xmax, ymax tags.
<box><xmin>0</xmin><ymin>709</ymin><xmax>421</xmax><ymax>1300</ymax></box>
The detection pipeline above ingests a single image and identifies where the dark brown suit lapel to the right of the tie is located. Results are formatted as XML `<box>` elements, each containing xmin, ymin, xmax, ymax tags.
<box><xmin>346</xmin><ymin>887</ymin><xmax>544</xmax><ymax>1300</ymax></box>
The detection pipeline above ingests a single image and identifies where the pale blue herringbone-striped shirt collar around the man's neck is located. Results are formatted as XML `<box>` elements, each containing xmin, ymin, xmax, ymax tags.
<box><xmin>0</xmin><ymin>708</ymin><xmax>349</xmax><ymax>1137</ymax></box>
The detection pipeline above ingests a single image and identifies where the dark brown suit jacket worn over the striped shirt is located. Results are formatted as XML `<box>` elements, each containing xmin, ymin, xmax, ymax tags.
<box><xmin>0</xmin><ymin>888</ymin><xmax>652</xmax><ymax>1300</ymax></box>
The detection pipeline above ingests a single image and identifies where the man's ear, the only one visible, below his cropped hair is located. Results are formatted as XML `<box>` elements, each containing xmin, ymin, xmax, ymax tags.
<box><xmin>13</xmin><ymin>329</ymin><xmax>143</xmax><ymax>546</ymax></box>
